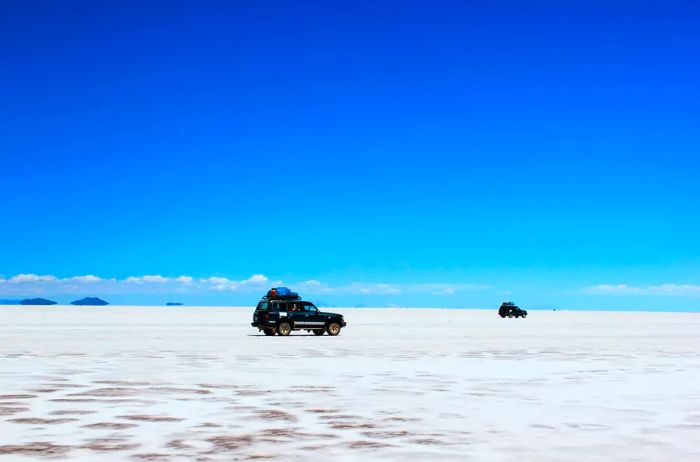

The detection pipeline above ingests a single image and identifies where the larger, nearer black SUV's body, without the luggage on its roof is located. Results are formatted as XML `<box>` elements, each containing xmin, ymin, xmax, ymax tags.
<box><xmin>251</xmin><ymin>297</ymin><xmax>345</xmax><ymax>335</ymax></box>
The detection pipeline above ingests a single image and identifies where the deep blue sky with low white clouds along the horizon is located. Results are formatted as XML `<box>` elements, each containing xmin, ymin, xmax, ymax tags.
<box><xmin>0</xmin><ymin>1</ymin><xmax>700</xmax><ymax>310</ymax></box>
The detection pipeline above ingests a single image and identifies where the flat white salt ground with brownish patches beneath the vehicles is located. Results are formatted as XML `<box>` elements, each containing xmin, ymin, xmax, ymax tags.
<box><xmin>0</xmin><ymin>307</ymin><xmax>700</xmax><ymax>462</ymax></box>
